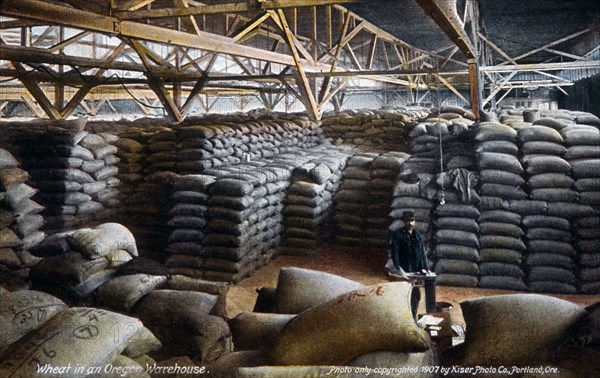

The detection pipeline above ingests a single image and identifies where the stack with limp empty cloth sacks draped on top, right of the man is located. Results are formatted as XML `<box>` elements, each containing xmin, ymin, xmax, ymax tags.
<box><xmin>430</xmin><ymin>169</ymin><xmax>481</xmax><ymax>287</ymax></box>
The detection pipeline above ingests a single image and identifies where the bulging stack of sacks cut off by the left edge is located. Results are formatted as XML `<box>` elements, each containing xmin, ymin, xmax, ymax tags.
<box><xmin>0</xmin><ymin>149</ymin><xmax>46</xmax><ymax>284</ymax></box>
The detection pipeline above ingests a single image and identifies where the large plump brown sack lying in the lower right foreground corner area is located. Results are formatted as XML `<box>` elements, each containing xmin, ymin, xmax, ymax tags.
<box><xmin>459</xmin><ymin>294</ymin><xmax>586</xmax><ymax>366</ymax></box>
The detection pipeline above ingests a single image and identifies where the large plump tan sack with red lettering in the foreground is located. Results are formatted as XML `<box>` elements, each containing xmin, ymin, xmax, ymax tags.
<box><xmin>271</xmin><ymin>282</ymin><xmax>428</xmax><ymax>365</ymax></box>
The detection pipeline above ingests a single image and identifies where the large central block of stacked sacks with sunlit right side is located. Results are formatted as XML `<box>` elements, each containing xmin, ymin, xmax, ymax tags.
<box><xmin>191</xmin><ymin>160</ymin><xmax>293</xmax><ymax>282</ymax></box>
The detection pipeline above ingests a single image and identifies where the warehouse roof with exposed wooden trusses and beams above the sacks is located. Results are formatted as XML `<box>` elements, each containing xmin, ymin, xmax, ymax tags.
<box><xmin>0</xmin><ymin>0</ymin><xmax>600</xmax><ymax>119</ymax></box>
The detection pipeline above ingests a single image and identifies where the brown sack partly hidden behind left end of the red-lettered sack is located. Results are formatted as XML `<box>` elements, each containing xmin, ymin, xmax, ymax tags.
<box><xmin>229</xmin><ymin>312</ymin><xmax>295</xmax><ymax>351</ymax></box>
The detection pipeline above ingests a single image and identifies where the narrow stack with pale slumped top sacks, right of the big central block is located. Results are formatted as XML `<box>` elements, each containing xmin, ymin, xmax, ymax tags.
<box><xmin>280</xmin><ymin>145</ymin><xmax>350</xmax><ymax>256</ymax></box>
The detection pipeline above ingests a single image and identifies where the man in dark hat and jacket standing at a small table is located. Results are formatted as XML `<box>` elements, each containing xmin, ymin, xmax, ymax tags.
<box><xmin>390</xmin><ymin>211</ymin><xmax>429</xmax><ymax>318</ymax></box>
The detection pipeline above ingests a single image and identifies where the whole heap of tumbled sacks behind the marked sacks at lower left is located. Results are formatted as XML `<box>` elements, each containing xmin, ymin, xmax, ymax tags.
<box><xmin>31</xmin><ymin>223</ymin><xmax>231</xmax><ymax>363</ymax></box>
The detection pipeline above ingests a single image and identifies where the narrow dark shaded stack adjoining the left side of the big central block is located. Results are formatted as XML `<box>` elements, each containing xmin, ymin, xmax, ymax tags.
<box><xmin>166</xmin><ymin>175</ymin><xmax>218</xmax><ymax>277</ymax></box>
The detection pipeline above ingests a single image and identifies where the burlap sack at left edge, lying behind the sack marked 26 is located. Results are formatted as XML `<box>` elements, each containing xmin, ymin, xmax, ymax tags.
<box><xmin>0</xmin><ymin>290</ymin><xmax>67</xmax><ymax>350</ymax></box>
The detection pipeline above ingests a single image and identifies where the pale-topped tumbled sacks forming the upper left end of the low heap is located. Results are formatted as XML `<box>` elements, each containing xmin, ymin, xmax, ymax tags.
<box><xmin>30</xmin><ymin>223</ymin><xmax>138</xmax><ymax>302</ymax></box>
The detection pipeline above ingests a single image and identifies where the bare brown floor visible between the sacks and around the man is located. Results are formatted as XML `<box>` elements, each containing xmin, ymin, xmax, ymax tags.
<box><xmin>227</xmin><ymin>246</ymin><xmax>600</xmax><ymax>326</ymax></box>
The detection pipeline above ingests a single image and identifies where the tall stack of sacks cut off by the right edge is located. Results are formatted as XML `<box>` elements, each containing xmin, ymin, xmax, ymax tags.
<box><xmin>560</xmin><ymin>113</ymin><xmax>600</xmax><ymax>294</ymax></box>
